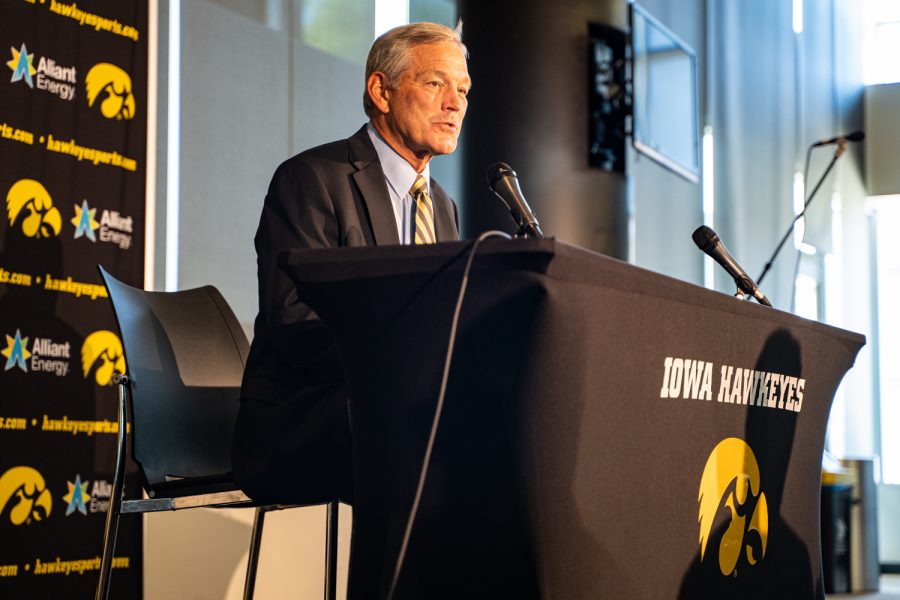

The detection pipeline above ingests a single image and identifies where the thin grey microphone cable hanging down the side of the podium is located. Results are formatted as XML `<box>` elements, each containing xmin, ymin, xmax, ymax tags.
<box><xmin>387</xmin><ymin>231</ymin><xmax>512</xmax><ymax>600</ymax></box>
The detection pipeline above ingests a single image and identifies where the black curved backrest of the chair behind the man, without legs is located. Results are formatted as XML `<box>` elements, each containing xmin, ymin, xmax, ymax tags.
<box><xmin>98</xmin><ymin>267</ymin><xmax>249</xmax><ymax>492</ymax></box>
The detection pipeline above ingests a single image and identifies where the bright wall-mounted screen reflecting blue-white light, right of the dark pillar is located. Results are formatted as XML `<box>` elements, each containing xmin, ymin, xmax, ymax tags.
<box><xmin>631</xmin><ymin>4</ymin><xmax>700</xmax><ymax>182</ymax></box>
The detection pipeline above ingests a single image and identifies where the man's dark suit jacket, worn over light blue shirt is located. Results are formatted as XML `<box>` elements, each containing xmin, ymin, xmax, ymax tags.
<box><xmin>232</xmin><ymin>126</ymin><xmax>459</xmax><ymax>503</ymax></box>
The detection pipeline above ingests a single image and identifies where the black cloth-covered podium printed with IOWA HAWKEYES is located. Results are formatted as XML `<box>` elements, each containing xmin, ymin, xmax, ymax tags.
<box><xmin>281</xmin><ymin>240</ymin><xmax>865</xmax><ymax>600</ymax></box>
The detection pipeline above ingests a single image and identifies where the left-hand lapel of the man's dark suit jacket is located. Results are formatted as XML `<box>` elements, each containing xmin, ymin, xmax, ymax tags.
<box><xmin>350</xmin><ymin>125</ymin><xmax>400</xmax><ymax>246</ymax></box>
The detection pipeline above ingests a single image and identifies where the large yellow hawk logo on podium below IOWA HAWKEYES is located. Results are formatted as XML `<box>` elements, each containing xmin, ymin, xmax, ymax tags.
<box><xmin>697</xmin><ymin>438</ymin><xmax>769</xmax><ymax>575</ymax></box>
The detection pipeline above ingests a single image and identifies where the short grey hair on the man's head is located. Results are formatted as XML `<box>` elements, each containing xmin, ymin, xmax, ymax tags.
<box><xmin>363</xmin><ymin>20</ymin><xmax>469</xmax><ymax>117</ymax></box>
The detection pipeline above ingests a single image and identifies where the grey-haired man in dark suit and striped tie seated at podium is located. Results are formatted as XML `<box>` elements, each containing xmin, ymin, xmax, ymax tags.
<box><xmin>233</xmin><ymin>23</ymin><xmax>470</xmax><ymax>503</ymax></box>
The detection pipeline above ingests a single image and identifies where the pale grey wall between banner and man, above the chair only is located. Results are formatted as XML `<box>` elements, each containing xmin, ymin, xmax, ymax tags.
<box><xmin>178</xmin><ymin>0</ymin><xmax>366</xmax><ymax>323</ymax></box>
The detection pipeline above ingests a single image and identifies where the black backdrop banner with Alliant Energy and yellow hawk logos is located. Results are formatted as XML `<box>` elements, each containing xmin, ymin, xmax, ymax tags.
<box><xmin>0</xmin><ymin>0</ymin><xmax>149</xmax><ymax>598</ymax></box>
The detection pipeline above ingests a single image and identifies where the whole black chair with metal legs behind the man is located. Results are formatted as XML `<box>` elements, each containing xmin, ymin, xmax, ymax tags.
<box><xmin>96</xmin><ymin>267</ymin><xmax>338</xmax><ymax>600</ymax></box>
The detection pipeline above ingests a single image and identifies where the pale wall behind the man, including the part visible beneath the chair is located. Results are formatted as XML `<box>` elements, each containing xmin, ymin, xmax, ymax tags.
<box><xmin>147</xmin><ymin>0</ymin><xmax>368</xmax><ymax>600</ymax></box>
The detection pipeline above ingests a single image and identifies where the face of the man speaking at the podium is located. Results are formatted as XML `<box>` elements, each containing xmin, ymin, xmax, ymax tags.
<box><xmin>382</xmin><ymin>43</ymin><xmax>471</xmax><ymax>166</ymax></box>
